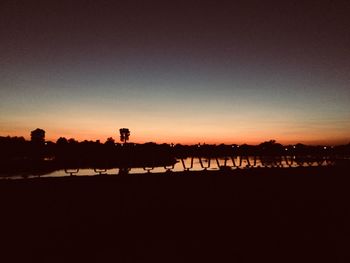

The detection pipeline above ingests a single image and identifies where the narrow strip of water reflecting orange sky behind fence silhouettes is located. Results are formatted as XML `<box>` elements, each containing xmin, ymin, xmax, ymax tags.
<box><xmin>2</xmin><ymin>156</ymin><xmax>332</xmax><ymax>179</ymax></box>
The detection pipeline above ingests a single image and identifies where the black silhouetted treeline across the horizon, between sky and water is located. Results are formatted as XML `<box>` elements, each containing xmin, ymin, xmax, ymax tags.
<box><xmin>0</xmin><ymin>137</ymin><xmax>350</xmax><ymax>174</ymax></box>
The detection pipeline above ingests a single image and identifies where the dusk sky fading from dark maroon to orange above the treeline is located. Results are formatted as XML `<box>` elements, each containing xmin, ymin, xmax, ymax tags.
<box><xmin>0</xmin><ymin>0</ymin><xmax>350</xmax><ymax>144</ymax></box>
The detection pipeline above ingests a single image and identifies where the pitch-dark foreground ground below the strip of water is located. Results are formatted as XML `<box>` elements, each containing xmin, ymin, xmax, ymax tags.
<box><xmin>0</xmin><ymin>167</ymin><xmax>350</xmax><ymax>262</ymax></box>
